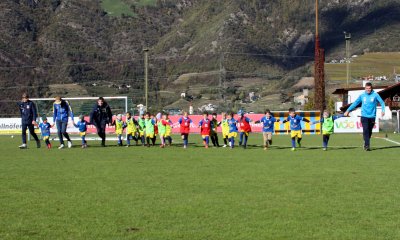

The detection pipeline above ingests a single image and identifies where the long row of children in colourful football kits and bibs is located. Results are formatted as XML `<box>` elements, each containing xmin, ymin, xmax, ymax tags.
<box><xmin>39</xmin><ymin>108</ymin><xmax>343</xmax><ymax>151</ymax></box>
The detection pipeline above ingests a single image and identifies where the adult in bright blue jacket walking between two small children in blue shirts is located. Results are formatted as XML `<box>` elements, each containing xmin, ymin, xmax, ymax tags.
<box><xmin>52</xmin><ymin>96</ymin><xmax>74</xmax><ymax>149</ymax></box>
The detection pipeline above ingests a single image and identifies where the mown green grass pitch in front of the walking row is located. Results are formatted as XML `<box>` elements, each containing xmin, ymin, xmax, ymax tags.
<box><xmin>0</xmin><ymin>134</ymin><xmax>400</xmax><ymax>240</ymax></box>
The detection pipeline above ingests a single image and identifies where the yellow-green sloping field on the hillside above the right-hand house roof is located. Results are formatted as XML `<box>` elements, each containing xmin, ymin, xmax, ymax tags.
<box><xmin>325</xmin><ymin>52</ymin><xmax>400</xmax><ymax>81</ymax></box>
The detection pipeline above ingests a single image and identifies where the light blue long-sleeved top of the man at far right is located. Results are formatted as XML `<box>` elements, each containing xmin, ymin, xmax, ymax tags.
<box><xmin>347</xmin><ymin>91</ymin><xmax>385</xmax><ymax>118</ymax></box>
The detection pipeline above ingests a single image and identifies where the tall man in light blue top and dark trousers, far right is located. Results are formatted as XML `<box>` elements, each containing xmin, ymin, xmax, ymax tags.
<box><xmin>344</xmin><ymin>83</ymin><xmax>385</xmax><ymax>151</ymax></box>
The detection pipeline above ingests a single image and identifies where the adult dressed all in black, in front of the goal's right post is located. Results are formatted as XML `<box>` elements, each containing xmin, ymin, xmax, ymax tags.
<box><xmin>90</xmin><ymin>97</ymin><xmax>112</xmax><ymax>147</ymax></box>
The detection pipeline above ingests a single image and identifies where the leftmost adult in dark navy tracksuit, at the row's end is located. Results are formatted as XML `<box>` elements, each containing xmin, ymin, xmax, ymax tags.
<box><xmin>18</xmin><ymin>93</ymin><xmax>40</xmax><ymax>149</ymax></box>
